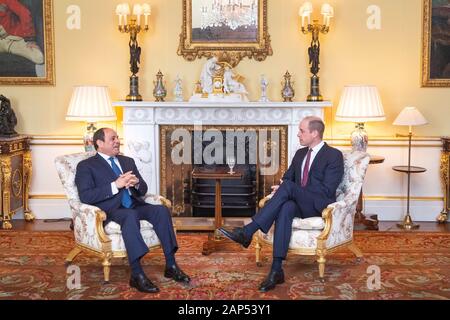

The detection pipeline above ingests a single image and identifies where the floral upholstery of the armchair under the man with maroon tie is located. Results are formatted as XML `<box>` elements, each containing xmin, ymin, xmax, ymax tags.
<box><xmin>260</xmin><ymin>151</ymin><xmax>370</xmax><ymax>249</ymax></box>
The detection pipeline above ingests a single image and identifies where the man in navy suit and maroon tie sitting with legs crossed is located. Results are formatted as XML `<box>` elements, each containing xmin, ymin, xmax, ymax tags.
<box><xmin>220</xmin><ymin>117</ymin><xmax>344</xmax><ymax>292</ymax></box>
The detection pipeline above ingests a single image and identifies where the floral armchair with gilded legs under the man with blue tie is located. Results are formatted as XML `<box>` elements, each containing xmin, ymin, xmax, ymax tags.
<box><xmin>55</xmin><ymin>151</ymin><xmax>171</xmax><ymax>282</ymax></box>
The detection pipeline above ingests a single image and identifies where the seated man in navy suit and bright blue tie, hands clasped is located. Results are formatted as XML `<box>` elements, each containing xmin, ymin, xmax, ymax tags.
<box><xmin>75</xmin><ymin>128</ymin><xmax>190</xmax><ymax>293</ymax></box>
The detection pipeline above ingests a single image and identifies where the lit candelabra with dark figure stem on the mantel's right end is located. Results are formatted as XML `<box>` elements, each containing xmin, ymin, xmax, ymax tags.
<box><xmin>298</xmin><ymin>2</ymin><xmax>334</xmax><ymax>101</ymax></box>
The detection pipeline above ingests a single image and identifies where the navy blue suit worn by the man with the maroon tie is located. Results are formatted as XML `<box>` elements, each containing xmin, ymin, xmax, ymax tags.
<box><xmin>252</xmin><ymin>143</ymin><xmax>344</xmax><ymax>259</ymax></box>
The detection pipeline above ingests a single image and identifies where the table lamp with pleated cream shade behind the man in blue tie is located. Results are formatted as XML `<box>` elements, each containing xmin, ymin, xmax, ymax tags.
<box><xmin>66</xmin><ymin>86</ymin><xmax>116</xmax><ymax>151</ymax></box>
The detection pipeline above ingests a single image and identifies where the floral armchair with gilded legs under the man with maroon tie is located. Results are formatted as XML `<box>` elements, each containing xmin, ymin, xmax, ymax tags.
<box><xmin>255</xmin><ymin>151</ymin><xmax>370</xmax><ymax>281</ymax></box>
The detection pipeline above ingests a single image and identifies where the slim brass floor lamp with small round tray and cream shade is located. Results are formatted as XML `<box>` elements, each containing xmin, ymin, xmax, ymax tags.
<box><xmin>393</xmin><ymin>107</ymin><xmax>428</xmax><ymax>230</ymax></box>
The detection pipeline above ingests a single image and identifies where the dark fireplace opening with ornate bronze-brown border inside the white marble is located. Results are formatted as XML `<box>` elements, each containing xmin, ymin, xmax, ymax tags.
<box><xmin>159</xmin><ymin>125</ymin><xmax>288</xmax><ymax>217</ymax></box>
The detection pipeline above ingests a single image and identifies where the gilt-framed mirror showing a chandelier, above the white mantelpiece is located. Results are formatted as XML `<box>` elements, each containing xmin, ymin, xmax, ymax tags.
<box><xmin>177</xmin><ymin>0</ymin><xmax>272</xmax><ymax>67</ymax></box>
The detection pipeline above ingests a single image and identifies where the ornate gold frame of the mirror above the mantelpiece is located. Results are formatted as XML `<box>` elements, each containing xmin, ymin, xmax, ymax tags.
<box><xmin>177</xmin><ymin>0</ymin><xmax>273</xmax><ymax>67</ymax></box>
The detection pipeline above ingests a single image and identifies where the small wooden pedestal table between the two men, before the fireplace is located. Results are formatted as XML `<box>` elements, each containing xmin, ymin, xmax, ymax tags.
<box><xmin>192</xmin><ymin>167</ymin><xmax>243</xmax><ymax>255</ymax></box>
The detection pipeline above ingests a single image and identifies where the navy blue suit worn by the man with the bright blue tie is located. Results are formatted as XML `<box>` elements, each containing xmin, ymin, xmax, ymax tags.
<box><xmin>75</xmin><ymin>154</ymin><xmax>178</xmax><ymax>263</ymax></box>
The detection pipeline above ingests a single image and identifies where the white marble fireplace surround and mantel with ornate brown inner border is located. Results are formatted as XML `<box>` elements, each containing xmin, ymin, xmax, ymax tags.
<box><xmin>114</xmin><ymin>101</ymin><xmax>332</xmax><ymax>230</ymax></box>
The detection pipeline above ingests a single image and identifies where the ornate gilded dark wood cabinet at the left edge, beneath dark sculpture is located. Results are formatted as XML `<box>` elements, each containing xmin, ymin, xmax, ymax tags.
<box><xmin>0</xmin><ymin>135</ymin><xmax>34</xmax><ymax>229</ymax></box>
